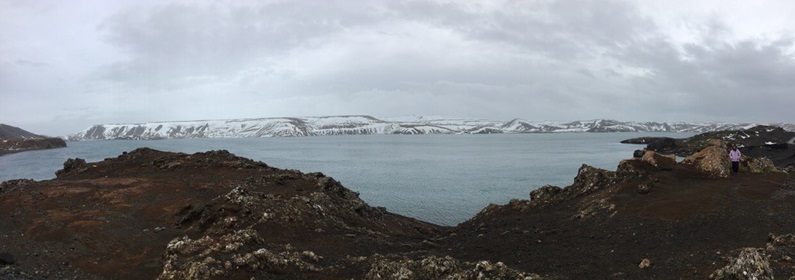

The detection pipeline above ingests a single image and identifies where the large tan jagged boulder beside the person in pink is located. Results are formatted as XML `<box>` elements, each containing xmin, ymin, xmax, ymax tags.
<box><xmin>682</xmin><ymin>139</ymin><xmax>731</xmax><ymax>177</ymax></box>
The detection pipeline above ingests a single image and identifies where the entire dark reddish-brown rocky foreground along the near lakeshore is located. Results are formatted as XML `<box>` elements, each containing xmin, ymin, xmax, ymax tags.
<box><xmin>0</xmin><ymin>140</ymin><xmax>795</xmax><ymax>279</ymax></box>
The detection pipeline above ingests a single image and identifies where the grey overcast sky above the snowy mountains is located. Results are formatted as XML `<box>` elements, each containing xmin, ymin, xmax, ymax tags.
<box><xmin>0</xmin><ymin>0</ymin><xmax>795</xmax><ymax>135</ymax></box>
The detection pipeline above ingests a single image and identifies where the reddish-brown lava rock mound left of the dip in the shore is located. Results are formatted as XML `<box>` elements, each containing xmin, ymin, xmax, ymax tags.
<box><xmin>0</xmin><ymin>148</ymin><xmax>445</xmax><ymax>279</ymax></box>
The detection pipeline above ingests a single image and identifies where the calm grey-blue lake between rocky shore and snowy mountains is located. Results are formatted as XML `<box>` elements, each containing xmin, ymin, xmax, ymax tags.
<box><xmin>0</xmin><ymin>133</ymin><xmax>694</xmax><ymax>225</ymax></box>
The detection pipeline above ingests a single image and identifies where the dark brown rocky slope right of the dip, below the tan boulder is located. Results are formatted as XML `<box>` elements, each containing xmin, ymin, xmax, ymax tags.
<box><xmin>444</xmin><ymin>143</ymin><xmax>795</xmax><ymax>279</ymax></box>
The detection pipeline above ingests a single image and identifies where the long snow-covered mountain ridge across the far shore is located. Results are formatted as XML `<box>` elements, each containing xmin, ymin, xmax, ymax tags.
<box><xmin>64</xmin><ymin>116</ymin><xmax>788</xmax><ymax>141</ymax></box>
